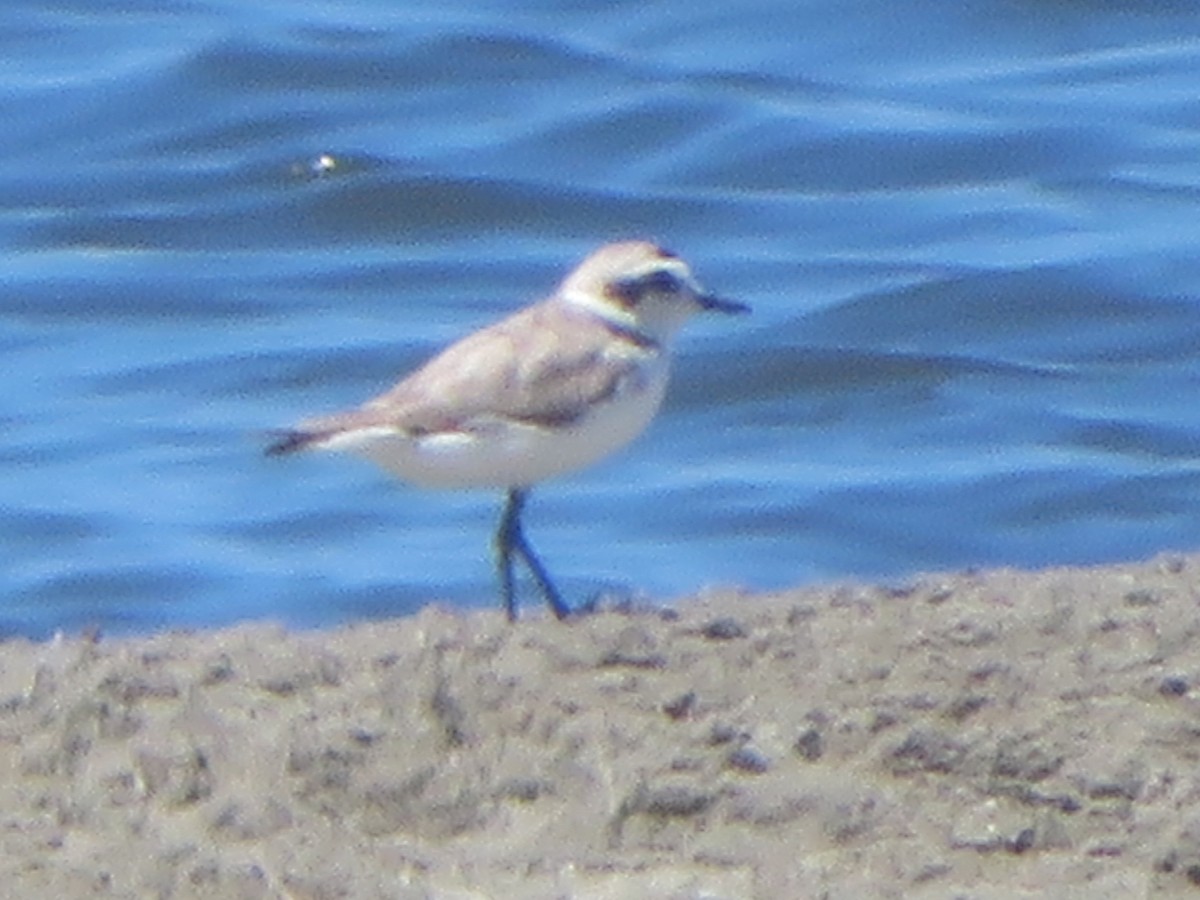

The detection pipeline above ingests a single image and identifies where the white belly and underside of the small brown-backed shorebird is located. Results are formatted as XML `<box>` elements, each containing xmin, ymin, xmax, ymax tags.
<box><xmin>323</xmin><ymin>367</ymin><xmax>667</xmax><ymax>488</ymax></box>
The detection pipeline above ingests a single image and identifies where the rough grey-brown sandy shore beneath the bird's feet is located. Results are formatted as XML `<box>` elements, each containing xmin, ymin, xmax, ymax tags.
<box><xmin>7</xmin><ymin>556</ymin><xmax>1200</xmax><ymax>900</ymax></box>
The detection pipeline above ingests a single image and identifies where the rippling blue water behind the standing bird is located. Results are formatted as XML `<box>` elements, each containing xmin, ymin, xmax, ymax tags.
<box><xmin>0</xmin><ymin>0</ymin><xmax>1200</xmax><ymax>637</ymax></box>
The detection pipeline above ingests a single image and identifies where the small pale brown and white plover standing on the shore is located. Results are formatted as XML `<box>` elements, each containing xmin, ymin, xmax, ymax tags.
<box><xmin>266</xmin><ymin>241</ymin><xmax>749</xmax><ymax>619</ymax></box>
